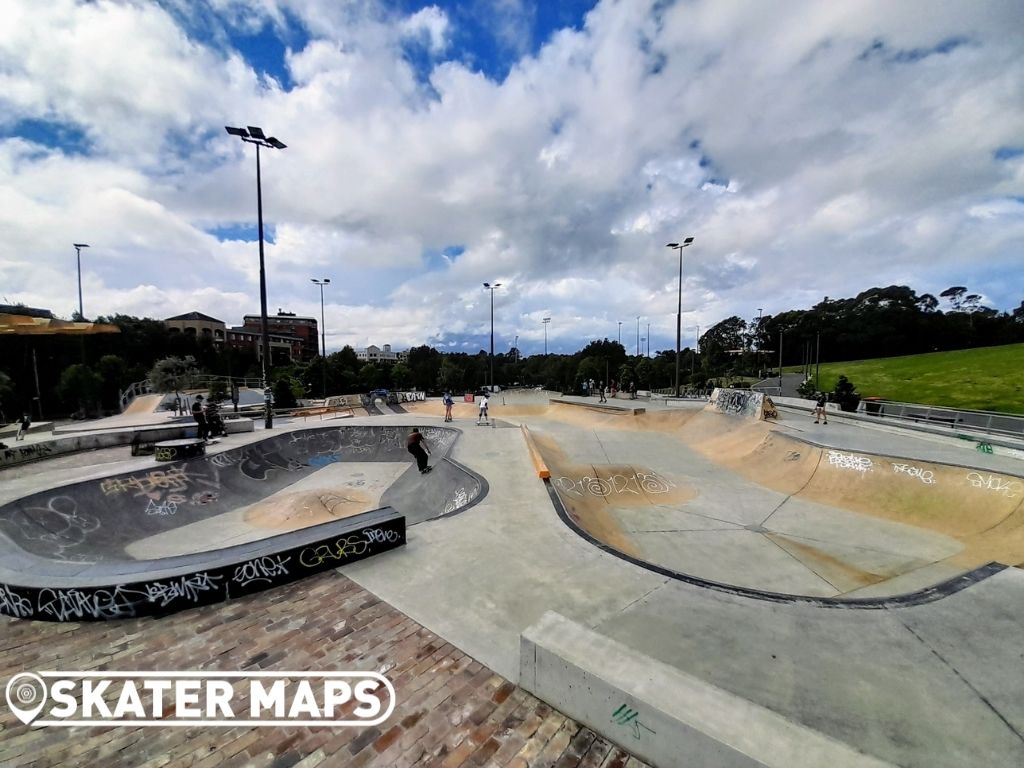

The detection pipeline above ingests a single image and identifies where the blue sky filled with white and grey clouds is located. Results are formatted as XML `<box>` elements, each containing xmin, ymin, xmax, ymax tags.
<box><xmin>0</xmin><ymin>0</ymin><xmax>1024</xmax><ymax>355</ymax></box>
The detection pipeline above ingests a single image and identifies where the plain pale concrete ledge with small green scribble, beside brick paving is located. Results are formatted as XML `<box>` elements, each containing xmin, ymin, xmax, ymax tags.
<box><xmin>519</xmin><ymin>611</ymin><xmax>892</xmax><ymax>768</ymax></box>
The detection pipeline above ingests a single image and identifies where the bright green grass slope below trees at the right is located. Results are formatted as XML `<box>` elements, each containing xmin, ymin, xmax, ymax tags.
<box><xmin>785</xmin><ymin>344</ymin><xmax>1024</xmax><ymax>414</ymax></box>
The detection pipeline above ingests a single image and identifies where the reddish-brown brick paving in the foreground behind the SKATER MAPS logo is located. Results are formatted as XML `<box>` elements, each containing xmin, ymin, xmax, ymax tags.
<box><xmin>0</xmin><ymin>571</ymin><xmax>644</xmax><ymax>768</ymax></box>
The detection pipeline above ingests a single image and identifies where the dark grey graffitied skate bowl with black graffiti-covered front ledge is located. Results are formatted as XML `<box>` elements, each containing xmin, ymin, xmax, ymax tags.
<box><xmin>0</xmin><ymin>426</ymin><xmax>487</xmax><ymax>621</ymax></box>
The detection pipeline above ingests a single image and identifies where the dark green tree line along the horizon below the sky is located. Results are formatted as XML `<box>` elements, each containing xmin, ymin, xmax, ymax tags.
<box><xmin>0</xmin><ymin>286</ymin><xmax>1024</xmax><ymax>421</ymax></box>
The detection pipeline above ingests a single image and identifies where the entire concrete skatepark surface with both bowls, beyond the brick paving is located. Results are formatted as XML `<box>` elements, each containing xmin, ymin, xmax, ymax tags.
<box><xmin>0</xmin><ymin>392</ymin><xmax>1024</xmax><ymax>766</ymax></box>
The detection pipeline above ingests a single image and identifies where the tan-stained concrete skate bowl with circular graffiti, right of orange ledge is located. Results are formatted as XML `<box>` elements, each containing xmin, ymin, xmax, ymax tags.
<box><xmin>531</xmin><ymin>403</ymin><xmax>1024</xmax><ymax>608</ymax></box>
